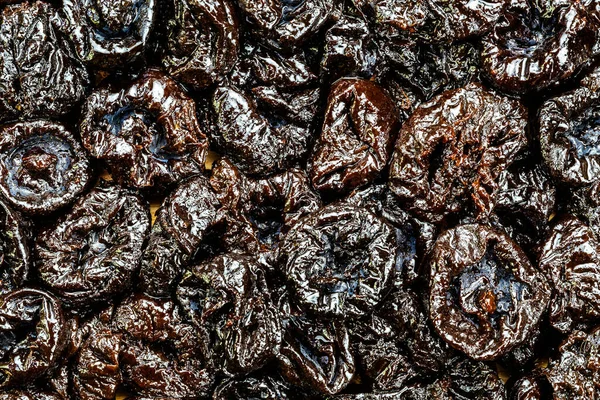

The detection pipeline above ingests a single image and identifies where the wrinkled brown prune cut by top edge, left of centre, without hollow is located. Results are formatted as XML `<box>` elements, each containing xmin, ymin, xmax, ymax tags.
<box><xmin>162</xmin><ymin>0</ymin><xmax>240</xmax><ymax>89</ymax></box>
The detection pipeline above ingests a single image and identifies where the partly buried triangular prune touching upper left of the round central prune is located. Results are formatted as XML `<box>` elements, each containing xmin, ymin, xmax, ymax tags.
<box><xmin>210</xmin><ymin>158</ymin><xmax>321</xmax><ymax>250</ymax></box>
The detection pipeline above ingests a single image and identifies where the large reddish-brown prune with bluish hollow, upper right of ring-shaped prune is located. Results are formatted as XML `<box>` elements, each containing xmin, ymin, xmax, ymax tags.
<box><xmin>80</xmin><ymin>70</ymin><xmax>208</xmax><ymax>189</ymax></box>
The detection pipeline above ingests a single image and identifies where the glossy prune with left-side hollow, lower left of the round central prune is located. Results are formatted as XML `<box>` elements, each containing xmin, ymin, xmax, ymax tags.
<box><xmin>176</xmin><ymin>253</ymin><xmax>281</xmax><ymax>374</ymax></box>
